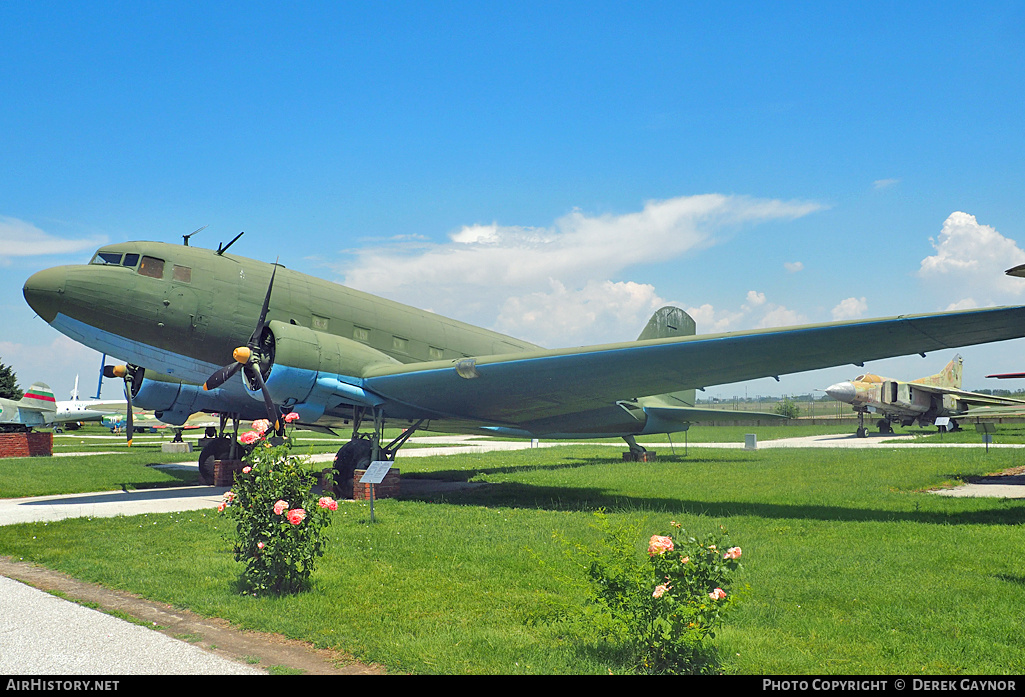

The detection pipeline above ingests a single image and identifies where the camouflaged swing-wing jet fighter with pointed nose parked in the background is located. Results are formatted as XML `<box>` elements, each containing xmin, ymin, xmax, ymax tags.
<box><xmin>825</xmin><ymin>356</ymin><xmax>1025</xmax><ymax>438</ymax></box>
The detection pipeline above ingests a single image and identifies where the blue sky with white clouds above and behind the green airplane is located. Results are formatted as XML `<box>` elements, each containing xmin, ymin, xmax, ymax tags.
<box><xmin>0</xmin><ymin>2</ymin><xmax>1025</xmax><ymax>397</ymax></box>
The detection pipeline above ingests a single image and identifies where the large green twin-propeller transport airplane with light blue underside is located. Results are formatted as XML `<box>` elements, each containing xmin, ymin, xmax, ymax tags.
<box><xmin>24</xmin><ymin>237</ymin><xmax>1025</xmax><ymax>481</ymax></box>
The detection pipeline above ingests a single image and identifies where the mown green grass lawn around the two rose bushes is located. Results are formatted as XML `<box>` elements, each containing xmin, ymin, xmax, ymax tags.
<box><xmin>0</xmin><ymin>434</ymin><xmax>1025</xmax><ymax>674</ymax></box>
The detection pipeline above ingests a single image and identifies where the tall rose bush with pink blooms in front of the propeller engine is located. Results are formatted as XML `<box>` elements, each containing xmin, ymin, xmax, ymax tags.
<box><xmin>218</xmin><ymin>414</ymin><xmax>337</xmax><ymax>595</ymax></box>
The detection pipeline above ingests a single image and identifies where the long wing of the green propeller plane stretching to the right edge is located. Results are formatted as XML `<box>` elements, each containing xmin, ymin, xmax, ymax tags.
<box><xmin>360</xmin><ymin>306</ymin><xmax>1025</xmax><ymax>423</ymax></box>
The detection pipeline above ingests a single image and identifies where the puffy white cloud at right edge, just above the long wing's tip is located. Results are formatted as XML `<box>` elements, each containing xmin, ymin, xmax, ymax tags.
<box><xmin>918</xmin><ymin>211</ymin><xmax>1025</xmax><ymax>306</ymax></box>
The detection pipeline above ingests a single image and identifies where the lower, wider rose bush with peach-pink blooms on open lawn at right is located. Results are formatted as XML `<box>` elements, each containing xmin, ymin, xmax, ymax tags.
<box><xmin>578</xmin><ymin>511</ymin><xmax>742</xmax><ymax>674</ymax></box>
